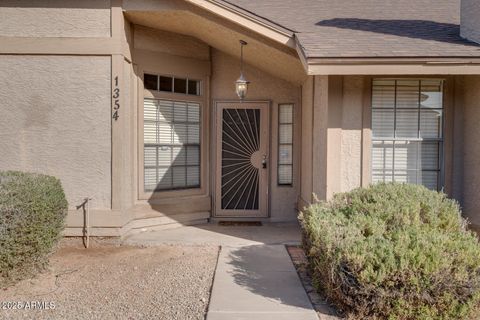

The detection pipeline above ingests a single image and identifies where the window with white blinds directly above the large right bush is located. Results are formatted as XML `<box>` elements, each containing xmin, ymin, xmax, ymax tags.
<box><xmin>372</xmin><ymin>79</ymin><xmax>444</xmax><ymax>190</ymax></box>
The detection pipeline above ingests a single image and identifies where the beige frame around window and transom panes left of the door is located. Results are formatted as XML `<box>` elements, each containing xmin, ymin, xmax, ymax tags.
<box><xmin>136</xmin><ymin>69</ymin><xmax>209</xmax><ymax>200</ymax></box>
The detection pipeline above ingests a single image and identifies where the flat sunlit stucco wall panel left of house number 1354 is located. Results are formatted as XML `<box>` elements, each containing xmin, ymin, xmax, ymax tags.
<box><xmin>0</xmin><ymin>56</ymin><xmax>111</xmax><ymax>208</ymax></box>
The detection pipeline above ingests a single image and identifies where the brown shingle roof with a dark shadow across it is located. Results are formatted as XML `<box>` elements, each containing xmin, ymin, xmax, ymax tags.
<box><xmin>224</xmin><ymin>0</ymin><xmax>480</xmax><ymax>58</ymax></box>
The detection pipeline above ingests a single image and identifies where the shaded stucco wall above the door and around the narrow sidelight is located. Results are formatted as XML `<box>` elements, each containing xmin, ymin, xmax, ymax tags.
<box><xmin>211</xmin><ymin>49</ymin><xmax>301</xmax><ymax>220</ymax></box>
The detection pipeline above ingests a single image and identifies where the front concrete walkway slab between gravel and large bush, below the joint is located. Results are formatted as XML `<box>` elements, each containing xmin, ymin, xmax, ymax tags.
<box><xmin>207</xmin><ymin>245</ymin><xmax>318</xmax><ymax>320</ymax></box>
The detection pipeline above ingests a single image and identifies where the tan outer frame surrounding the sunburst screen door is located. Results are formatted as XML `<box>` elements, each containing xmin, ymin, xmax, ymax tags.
<box><xmin>210</xmin><ymin>100</ymin><xmax>272</xmax><ymax>220</ymax></box>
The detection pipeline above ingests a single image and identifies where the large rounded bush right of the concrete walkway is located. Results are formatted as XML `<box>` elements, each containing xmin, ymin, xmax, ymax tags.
<box><xmin>300</xmin><ymin>184</ymin><xmax>480</xmax><ymax>320</ymax></box>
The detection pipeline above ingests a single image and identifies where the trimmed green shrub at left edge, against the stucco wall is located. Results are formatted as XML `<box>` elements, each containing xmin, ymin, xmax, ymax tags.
<box><xmin>0</xmin><ymin>171</ymin><xmax>67</xmax><ymax>287</ymax></box>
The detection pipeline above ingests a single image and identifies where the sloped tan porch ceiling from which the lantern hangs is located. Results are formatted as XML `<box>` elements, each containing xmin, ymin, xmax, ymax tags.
<box><xmin>124</xmin><ymin>1</ymin><xmax>307</xmax><ymax>84</ymax></box>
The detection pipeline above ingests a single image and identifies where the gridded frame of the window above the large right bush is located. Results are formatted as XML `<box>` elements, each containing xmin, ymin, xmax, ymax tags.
<box><xmin>369</xmin><ymin>77</ymin><xmax>449</xmax><ymax>191</ymax></box>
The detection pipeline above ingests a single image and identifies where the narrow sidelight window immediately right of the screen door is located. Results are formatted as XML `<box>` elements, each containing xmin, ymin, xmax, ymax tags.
<box><xmin>277</xmin><ymin>104</ymin><xmax>293</xmax><ymax>186</ymax></box>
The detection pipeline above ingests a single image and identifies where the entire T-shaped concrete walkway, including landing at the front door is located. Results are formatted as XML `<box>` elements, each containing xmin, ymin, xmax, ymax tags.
<box><xmin>124</xmin><ymin>223</ymin><xmax>318</xmax><ymax>320</ymax></box>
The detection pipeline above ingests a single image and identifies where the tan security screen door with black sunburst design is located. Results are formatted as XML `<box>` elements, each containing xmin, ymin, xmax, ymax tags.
<box><xmin>215</xmin><ymin>102</ymin><xmax>269</xmax><ymax>218</ymax></box>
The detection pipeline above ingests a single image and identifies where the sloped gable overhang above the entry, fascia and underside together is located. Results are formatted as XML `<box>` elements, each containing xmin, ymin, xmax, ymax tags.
<box><xmin>123</xmin><ymin>0</ymin><xmax>307</xmax><ymax>84</ymax></box>
